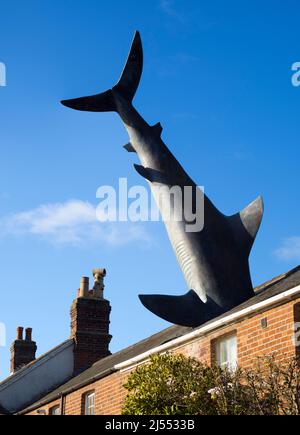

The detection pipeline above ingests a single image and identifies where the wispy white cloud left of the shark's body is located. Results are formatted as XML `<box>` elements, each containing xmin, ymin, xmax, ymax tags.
<box><xmin>0</xmin><ymin>200</ymin><xmax>150</xmax><ymax>246</ymax></box>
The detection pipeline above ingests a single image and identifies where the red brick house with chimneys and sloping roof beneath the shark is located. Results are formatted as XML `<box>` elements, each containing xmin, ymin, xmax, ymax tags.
<box><xmin>0</xmin><ymin>267</ymin><xmax>300</xmax><ymax>415</ymax></box>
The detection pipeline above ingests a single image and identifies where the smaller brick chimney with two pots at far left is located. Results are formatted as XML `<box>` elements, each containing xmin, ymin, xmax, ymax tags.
<box><xmin>10</xmin><ymin>326</ymin><xmax>37</xmax><ymax>373</ymax></box>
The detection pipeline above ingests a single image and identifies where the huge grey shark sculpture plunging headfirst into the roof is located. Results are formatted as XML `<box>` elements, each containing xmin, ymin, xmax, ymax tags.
<box><xmin>62</xmin><ymin>32</ymin><xmax>263</xmax><ymax>327</ymax></box>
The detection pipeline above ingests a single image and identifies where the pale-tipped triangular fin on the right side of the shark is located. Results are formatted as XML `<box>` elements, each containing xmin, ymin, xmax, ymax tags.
<box><xmin>228</xmin><ymin>196</ymin><xmax>264</xmax><ymax>256</ymax></box>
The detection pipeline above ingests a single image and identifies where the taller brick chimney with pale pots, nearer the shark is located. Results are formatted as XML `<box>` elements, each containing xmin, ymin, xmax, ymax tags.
<box><xmin>71</xmin><ymin>269</ymin><xmax>111</xmax><ymax>374</ymax></box>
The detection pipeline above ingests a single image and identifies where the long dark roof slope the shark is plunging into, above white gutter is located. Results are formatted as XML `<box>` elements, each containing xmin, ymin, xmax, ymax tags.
<box><xmin>18</xmin><ymin>266</ymin><xmax>300</xmax><ymax>413</ymax></box>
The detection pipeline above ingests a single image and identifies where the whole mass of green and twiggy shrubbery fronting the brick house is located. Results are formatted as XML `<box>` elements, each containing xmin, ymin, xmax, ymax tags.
<box><xmin>122</xmin><ymin>354</ymin><xmax>300</xmax><ymax>415</ymax></box>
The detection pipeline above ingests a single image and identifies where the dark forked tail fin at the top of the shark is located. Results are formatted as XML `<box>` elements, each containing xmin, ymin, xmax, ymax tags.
<box><xmin>61</xmin><ymin>32</ymin><xmax>143</xmax><ymax>112</ymax></box>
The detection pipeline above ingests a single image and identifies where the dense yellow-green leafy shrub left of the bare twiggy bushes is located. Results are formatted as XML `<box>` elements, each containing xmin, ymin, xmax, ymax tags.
<box><xmin>123</xmin><ymin>354</ymin><xmax>215</xmax><ymax>415</ymax></box>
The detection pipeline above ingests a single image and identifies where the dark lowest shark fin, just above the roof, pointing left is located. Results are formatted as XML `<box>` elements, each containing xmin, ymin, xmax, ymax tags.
<box><xmin>139</xmin><ymin>290</ymin><xmax>221</xmax><ymax>328</ymax></box>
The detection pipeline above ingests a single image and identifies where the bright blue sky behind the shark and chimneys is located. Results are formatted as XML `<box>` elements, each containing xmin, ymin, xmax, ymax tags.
<box><xmin>0</xmin><ymin>0</ymin><xmax>300</xmax><ymax>377</ymax></box>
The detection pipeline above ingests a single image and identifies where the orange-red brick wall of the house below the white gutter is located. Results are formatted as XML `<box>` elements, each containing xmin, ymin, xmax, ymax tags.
<box><xmin>25</xmin><ymin>298</ymin><xmax>300</xmax><ymax>415</ymax></box>
